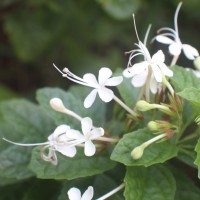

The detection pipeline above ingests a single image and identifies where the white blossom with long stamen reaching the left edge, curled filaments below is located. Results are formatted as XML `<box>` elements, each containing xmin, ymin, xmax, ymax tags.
<box><xmin>3</xmin><ymin>125</ymin><xmax>76</xmax><ymax>165</ymax></box>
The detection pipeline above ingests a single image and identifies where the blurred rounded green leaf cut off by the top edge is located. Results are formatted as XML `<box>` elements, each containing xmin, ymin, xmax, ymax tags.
<box><xmin>97</xmin><ymin>0</ymin><xmax>140</xmax><ymax>19</ymax></box>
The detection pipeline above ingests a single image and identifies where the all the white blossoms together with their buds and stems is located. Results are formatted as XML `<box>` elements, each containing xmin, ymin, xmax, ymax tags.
<box><xmin>3</xmin><ymin>3</ymin><xmax>200</xmax><ymax>200</ymax></box>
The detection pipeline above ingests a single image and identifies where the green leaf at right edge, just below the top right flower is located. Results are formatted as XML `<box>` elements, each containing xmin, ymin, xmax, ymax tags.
<box><xmin>170</xmin><ymin>66</ymin><xmax>200</xmax><ymax>92</ymax></box>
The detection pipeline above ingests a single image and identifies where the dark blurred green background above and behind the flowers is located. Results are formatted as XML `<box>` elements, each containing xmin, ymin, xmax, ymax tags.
<box><xmin>0</xmin><ymin>0</ymin><xmax>200</xmax><ymax>100</ymax></box>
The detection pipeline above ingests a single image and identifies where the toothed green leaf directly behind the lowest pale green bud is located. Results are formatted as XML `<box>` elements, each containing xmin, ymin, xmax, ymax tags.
<box><xmin>111</xmin><ymin>129</ymin><xmax>178</xmax><ymax>167</ymax></box>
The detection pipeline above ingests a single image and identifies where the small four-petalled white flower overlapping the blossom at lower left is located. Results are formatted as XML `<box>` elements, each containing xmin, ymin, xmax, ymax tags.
<box><xmin>66</xmin><ymin>117</ymin><xmax>104</xmax><ymax>156</ymax></box>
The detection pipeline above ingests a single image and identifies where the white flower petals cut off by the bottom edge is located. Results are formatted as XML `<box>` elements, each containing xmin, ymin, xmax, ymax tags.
<box><xmin>67</xmin><ymin>186</ymin><xmax>94</xmax><ymax>200</ymax></box>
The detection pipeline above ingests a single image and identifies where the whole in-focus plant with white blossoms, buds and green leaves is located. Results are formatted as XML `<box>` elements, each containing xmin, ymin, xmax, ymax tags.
<box><xmin>0</xmin><ymin>3</ymin><xmax>200</xmax><ymax>200</ymax></box>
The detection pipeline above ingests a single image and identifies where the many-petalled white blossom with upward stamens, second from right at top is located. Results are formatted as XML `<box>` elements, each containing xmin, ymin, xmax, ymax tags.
<box><xmin>123</xmin><ymin>16</ymin><xmax>173</xmax><ymax>97</ymax></box>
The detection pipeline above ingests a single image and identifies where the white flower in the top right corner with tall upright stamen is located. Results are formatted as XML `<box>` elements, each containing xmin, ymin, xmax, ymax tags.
<box><xmin>155</xmin><ymin>2</ymin><xmax>199</xmax><ymax>60</ymax></box>
